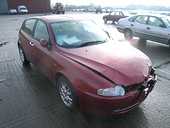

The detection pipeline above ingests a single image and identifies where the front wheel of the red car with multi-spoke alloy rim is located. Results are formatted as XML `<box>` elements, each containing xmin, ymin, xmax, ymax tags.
<box><xmin>56</xmin><ymin>76</ymin><xmax>78</xmax><ymax>110</ymax></box>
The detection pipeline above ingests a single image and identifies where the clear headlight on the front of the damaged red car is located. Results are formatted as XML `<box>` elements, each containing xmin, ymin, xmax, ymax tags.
<box><xmin>97</xmin><ymin>85</ymin><xmax>125</xmax><ymax>96</ymax></box>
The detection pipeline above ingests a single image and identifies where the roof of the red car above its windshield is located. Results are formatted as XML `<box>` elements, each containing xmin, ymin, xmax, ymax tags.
<box><xmin>28</xmin><ymin>15</ymin><xmax>84</xmax><ymax>23</ymax></box>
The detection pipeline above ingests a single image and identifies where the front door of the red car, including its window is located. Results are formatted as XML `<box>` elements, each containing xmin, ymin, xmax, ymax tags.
<box><xmin>32</xmin><ymin>20</ymin><xmax>55</xmax><ymax>79</ymax></box>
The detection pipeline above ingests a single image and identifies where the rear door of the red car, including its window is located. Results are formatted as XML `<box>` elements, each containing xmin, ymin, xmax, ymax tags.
<box><xmin>18</xmin><ymin>19</ymin><xmax>36</xmax><ymax>62</ymax></box>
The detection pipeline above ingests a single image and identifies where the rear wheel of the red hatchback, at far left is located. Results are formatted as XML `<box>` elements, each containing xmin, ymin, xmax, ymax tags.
<box><xmin>18</xmin><ymin>45</ymin><xmax>30</xmax><ymax>66</ymax></box>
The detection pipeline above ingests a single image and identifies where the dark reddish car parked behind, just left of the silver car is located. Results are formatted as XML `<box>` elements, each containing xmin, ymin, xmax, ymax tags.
<box><xmin>103</xmin><ymin>11</ymin><xmax>127</xmax><ymax>24</ymax></box>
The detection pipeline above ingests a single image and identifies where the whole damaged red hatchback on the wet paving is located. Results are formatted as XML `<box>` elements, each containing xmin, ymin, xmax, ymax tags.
<box><xmin>18</xmin><ymin>15</ymin><xmax>156</xmax><ymax>114</ymax></box>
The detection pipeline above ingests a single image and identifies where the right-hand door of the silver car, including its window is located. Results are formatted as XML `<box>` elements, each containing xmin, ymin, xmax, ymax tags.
<box><xmin>145</xmin><ymin>16</ymin><xmax>169</xmax><ymax>44</ymax></box>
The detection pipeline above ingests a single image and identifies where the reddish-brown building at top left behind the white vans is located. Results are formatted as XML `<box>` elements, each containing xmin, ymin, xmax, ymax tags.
<box><xmin>0</xmin><ymin>0</ymin><xmax>50</xmax><ymax>13</ymax></box>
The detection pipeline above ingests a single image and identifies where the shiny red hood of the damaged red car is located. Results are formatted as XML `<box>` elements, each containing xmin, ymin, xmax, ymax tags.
<box><xmin>60</xmin><ymin>42</ymin><xmax>152</xmax><ymax>86</ymax></box>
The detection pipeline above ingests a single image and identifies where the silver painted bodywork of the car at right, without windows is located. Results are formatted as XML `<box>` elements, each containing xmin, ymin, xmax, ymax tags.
<box><xmin>117</xmin><ymin>15</ymin><xmax>170</xmax><ymax>45</ymax></box>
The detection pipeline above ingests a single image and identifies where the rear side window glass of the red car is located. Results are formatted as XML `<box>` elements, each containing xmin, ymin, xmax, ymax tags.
<box><xmin>21</xmin><ymin>19</ymin><xmax>36</xmax><ymax>35</ymax></box>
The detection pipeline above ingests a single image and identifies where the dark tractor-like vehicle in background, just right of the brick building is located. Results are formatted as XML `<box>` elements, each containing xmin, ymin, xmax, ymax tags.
<box><xmin>52</xmin><ymin>3</ymin><xmax>65</xmax><ymax>14</ymax></box>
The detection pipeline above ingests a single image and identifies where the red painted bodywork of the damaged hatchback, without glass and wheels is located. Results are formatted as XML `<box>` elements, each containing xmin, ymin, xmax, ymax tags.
<box><xmin>19</xmin><ymin>16</ymin><xmax>157</xmax><ymax>114</ymax></box>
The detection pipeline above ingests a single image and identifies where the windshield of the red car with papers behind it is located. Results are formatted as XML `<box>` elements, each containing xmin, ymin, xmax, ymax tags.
<box><xmin>51</xmin><ymin>21</ymin><xmax>109</xmax><ymax>48</ymax></box>
